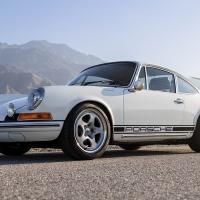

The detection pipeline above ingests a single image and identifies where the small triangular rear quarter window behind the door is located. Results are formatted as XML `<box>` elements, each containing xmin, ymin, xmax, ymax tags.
<box><xmin>177</xmin><ymin>77</ymin><xmax>197</xmax><ymax>94</ymax></box>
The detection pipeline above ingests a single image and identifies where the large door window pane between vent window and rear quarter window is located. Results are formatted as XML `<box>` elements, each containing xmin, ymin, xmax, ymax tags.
<box><xmin>147</xmin><ymin>67</ymin><xmax>176</xmax><ymax>93</ymax></box>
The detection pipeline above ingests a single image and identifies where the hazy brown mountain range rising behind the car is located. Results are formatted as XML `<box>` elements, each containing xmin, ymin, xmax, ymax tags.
<box><xmin>0</xmin><ymin>41</ymin><xmax>103</xmax><ymax>93</ymax></box>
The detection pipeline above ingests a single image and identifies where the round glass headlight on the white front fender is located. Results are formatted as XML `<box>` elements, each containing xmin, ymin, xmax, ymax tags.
<box><xmin>28</xmin><ymin>88</ymin><xmax>44</xmax><ymax>110</ymax></box>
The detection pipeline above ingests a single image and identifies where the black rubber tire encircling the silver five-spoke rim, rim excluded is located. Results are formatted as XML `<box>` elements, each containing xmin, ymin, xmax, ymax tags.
<box><xmin>59</xmin><ymin>103</ymin><xmax>111</xmax><ymax>160</ymax></box>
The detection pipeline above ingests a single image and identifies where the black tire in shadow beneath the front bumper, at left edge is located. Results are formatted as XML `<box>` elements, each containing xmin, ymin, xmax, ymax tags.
<box><xmin>0</xmin><ymin>143</ymin><xmax>31</xmax><ymax>156</ymax></box>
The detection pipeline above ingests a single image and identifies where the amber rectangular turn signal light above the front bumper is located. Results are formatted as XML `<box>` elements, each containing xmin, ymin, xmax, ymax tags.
<box><xmin>17</xmin><ymin>113</ymin><xmax>53</xmax><ymax>121</ymax></box>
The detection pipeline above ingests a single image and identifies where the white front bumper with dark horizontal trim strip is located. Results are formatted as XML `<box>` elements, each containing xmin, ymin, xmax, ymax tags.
<box><xmin>0</xmin><ymin>121</ymin><xmax>64</xmax><ymax>142</ymax></box>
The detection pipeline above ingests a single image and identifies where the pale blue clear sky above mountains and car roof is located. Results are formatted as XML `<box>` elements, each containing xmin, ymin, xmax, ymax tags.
<box><xmin>0</xmin><ymin>0</ymin><xmax>200</xmax><ymax>77</ymax></box>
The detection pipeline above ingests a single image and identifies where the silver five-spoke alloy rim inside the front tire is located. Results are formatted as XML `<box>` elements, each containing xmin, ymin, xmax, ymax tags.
<box><xmin>74</xmin><ymin>109</ymin><xmax>107</xmax><ymax>153</ymax></box>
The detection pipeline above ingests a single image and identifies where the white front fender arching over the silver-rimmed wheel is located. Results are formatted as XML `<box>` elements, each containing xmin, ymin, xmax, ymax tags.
<box><xmin>34</xmin><ymin>86</ymin><xmax>123</xmax><ymax>124</ymax></box>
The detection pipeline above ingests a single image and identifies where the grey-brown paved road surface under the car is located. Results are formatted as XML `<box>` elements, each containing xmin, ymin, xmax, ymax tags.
<box><xmin>0</xmin><ymin>146</ymin><xmax>200</xmax><ymax>200</ymax></box>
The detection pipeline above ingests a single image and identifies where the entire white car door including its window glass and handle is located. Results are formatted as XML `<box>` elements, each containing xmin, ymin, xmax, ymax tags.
<box><xmin>124</xmin><ymin>66</ymin><xmax>184</xmax><ymax>126</ymax></box>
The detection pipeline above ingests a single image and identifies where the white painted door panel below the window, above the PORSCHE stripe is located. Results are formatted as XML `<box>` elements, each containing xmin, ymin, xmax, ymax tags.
<box><xmin>124</xmin><ymin>90</ymin><xmax>185</xmax><ymax>125</ymax></box>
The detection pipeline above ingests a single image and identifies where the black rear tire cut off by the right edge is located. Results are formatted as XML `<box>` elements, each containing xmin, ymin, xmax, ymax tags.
<box><xmin>188</xmin><ymin>120</ymin><xmax>200</xmax><ymax>153</ymax></box>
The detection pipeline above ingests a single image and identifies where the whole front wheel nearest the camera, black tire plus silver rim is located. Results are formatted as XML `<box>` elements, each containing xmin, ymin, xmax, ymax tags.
<box><xmin>60</xmin><ymin>103</ymin><xmax>111</xmax><ymax>159</ymax></box>
